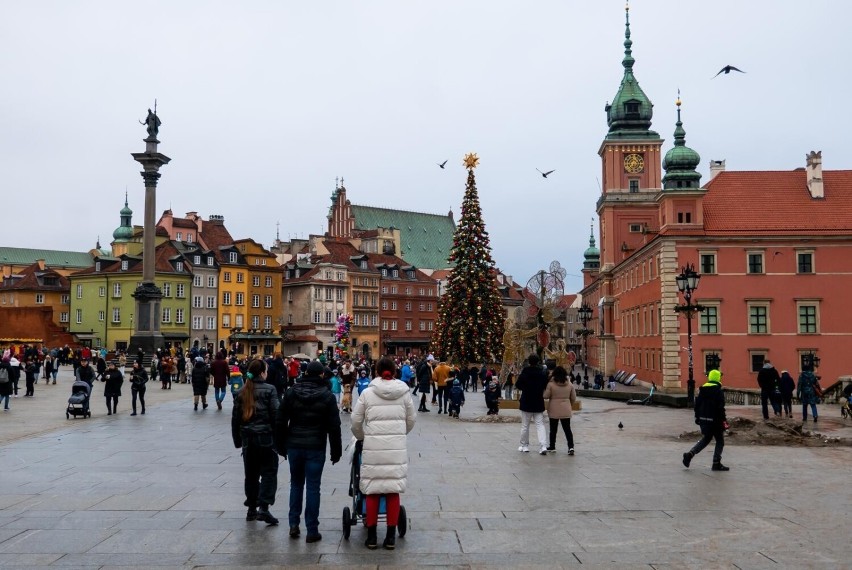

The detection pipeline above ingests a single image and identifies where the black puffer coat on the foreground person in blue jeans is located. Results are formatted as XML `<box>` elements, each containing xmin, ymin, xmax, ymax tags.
<box><xmin>275</xmin><ymin>376</ymin><xmax>343</xmax><ymax>461</ymax></box>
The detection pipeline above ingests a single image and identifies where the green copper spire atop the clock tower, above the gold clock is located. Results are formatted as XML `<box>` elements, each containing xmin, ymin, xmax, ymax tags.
<box><xmin>604</xmin><ymin>7</ymin><xmax>660</xmax><ymax>139</ymax></box>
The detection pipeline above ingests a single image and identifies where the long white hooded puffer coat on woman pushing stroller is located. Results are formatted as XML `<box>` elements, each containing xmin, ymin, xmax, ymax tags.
<box><xmin>351</xmin><ymin>378</ymin><xmax>415</xmax><ymax>495</ymax></box>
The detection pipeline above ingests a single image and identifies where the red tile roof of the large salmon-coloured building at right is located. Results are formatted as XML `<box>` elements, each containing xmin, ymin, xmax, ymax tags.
<box><xmin>703</xmin><ymin>170</ymin><xmax>852</xmax><ymax>236</ymax></box>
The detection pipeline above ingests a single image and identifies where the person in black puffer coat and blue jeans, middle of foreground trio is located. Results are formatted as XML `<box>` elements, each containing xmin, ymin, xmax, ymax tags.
<box><xmin>275</xmin><ymin>361</ymin><xmax>343</xmax><ymax>542</ymax></box>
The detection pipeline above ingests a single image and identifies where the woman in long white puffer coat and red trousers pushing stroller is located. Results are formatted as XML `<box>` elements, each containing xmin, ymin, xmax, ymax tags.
<box><xmin>352</xmin><ymin>358</ymin><xmax>416</xmax><ymax>550</ymax></box>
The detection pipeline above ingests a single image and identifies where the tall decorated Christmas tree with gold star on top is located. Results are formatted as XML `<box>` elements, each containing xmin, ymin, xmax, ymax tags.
<box><xmin>431</xmin><ymin>153</ymin><xmax>504</xmax><ymax>365</ymax></box>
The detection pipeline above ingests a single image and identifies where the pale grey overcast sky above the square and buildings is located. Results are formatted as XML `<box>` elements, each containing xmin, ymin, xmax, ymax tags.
<box><xmin>0</xmin><ymin>0</ymin><xmax>852</xmax><ymax>291</ymax></box>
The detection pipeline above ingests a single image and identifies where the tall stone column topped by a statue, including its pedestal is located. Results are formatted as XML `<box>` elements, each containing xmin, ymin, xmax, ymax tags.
<box><xmin>130</xmin><ymin>105</ymin><xmax>171</xmax><ymax>354</ymax></box>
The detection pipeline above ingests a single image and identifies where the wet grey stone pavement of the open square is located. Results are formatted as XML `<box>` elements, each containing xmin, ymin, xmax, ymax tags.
<box><xmin>0</xmin><ymin>370</ymin><xmax>852</xmax><ymax>568</ymax></box>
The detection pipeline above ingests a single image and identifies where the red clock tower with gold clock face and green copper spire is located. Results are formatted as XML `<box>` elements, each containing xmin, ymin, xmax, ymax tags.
<box><xmin>597</xmin><ymin>2</ymin><xmax>663</xmax><ymax>271</ymax></box>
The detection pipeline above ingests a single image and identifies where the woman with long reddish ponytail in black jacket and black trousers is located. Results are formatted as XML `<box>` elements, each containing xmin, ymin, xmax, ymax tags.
<box><xmin>231</xmin><ymin>359</ymin><xmax>278</xmax><ymax>525</ymax></box>
